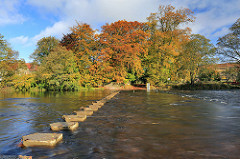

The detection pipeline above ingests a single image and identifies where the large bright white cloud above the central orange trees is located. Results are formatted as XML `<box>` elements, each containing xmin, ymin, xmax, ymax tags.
<box><xmin>28</xmin><ymin>0</ymin><xmax>165</xmax><ymax>41</ymax></box>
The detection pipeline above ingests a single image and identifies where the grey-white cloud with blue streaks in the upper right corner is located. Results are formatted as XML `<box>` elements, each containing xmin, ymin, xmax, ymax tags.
<box><xmin>176</xmin><ymin>0</ymin><xmax>240</xmax><ymax>39</ymax></box>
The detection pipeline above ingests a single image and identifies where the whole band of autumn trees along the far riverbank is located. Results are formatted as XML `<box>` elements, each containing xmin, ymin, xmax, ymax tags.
<box><xmin>0</xmin><ymin>5</ymin><xmax>225</xmax><ymax>90</ymax></box>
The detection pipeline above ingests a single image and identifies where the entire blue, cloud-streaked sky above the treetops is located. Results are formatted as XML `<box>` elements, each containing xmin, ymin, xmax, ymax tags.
<box><xmin>0</xmin><ymin>0</ymin><xmax>240</xmax><ymax>62</ymax></box>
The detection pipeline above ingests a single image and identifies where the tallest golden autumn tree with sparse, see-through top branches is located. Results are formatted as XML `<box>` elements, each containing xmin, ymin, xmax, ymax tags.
<box><xmin>146</xmin><ymin>5</ymin><xmax>194</xmax><ymax>84</ymax></box>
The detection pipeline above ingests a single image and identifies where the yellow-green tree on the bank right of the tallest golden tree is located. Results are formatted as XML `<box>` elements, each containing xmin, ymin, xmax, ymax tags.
<box><xmin>182</xmin><ymin>34</ymin><xmax>215</xmax><ymax>85</ymax></box>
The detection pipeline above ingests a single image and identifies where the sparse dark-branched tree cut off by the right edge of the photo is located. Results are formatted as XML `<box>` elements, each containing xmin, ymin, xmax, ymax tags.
<box><xmin>217</xmin><ymin>18</ymin><xmax>240</xmax><ymax>63</ymax></box>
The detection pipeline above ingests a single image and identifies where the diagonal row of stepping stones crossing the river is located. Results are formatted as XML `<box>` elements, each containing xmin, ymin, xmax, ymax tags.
<box><xmin>19</xmin><ymin>92</ymin><xmax>119</xmax><ymax>147</ymax></box>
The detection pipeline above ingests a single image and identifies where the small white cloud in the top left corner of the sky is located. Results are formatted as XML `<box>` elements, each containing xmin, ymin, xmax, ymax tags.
<box><xmin>0</xmin><ymin>0</ymin><xmax>26</xmax><ymax>25</ymax></box>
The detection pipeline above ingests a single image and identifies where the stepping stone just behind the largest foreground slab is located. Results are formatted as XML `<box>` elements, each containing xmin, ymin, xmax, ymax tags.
<box><xmin>50</xmin><ymin>122</ymin><xmax>79</xmax><ymax>131</ymax></box>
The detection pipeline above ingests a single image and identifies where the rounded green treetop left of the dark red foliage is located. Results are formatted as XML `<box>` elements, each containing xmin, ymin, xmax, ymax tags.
<box><xmin>30</xmin><ymin>36</ymin><xmax>59</xmax><ymax>64</ymax></box>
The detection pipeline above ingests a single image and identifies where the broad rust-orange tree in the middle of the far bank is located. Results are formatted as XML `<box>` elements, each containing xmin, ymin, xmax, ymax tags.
<box><xmin>100</xmin><ymin>20</ymin><xmax>148</xmax><ymax>83</ymax></box>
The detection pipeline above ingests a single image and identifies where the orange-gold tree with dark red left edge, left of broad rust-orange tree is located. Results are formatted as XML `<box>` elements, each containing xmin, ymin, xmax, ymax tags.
<box><xmin>60</xmin><ymin>22</ymin><xmax>108</xmax><ymax>86</ymax></box>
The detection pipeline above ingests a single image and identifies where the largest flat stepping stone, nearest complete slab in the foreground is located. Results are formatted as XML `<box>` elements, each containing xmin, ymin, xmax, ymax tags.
<box><xmin>22</xmin><ymin>133</ymin><xmax>63</xmax><ymax>147</ymax></box>
